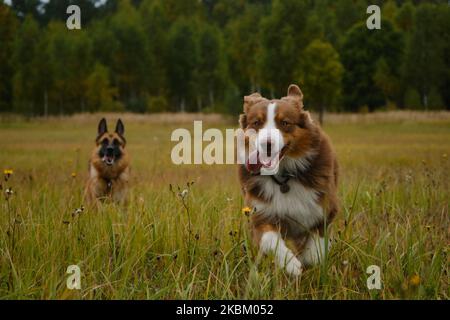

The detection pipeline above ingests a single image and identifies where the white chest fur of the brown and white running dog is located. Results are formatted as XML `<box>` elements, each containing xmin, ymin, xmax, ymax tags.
<box><xmin>252</xmin><ymin>176</ymin><xmax>324</xmax><ymax>229</ymax></box>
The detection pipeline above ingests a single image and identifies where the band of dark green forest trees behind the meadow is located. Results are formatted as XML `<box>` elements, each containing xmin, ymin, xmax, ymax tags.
<box><xmin>0</xmin><ymin>0</ymin><xmax>450</xmax><ymax>115</ymax></box>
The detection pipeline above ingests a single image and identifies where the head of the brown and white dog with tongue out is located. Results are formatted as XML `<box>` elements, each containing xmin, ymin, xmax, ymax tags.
<box><xmin>240</xmin><ymin>85</ymin><xmax>312</xmax><ymax>175</ymax></box>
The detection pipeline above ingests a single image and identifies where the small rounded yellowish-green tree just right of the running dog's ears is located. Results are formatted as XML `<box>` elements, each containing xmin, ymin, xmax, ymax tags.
<box><xmin>297</xmin><ymin>40</ymin><xmax>344</xmax><ymax>123</ymax></box>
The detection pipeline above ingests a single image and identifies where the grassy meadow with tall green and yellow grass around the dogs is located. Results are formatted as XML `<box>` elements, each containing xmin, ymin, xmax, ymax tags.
<box><xmin>0</xmin><ymin>113</ymin><xmax>450</xmax><ymax>299</ymax></box>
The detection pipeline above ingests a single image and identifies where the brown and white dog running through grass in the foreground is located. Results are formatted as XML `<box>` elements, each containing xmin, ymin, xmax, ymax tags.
<box><xmin>239</xmin><ymin>85</ymin><xmax>338</xmax><ymax>275</ymax></box>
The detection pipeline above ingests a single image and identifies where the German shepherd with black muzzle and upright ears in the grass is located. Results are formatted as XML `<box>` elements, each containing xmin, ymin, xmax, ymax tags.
<box><xmin>85</xmin><ymin>118</ymin><xmax>130</xmax><ymax>203</ymax></box>
